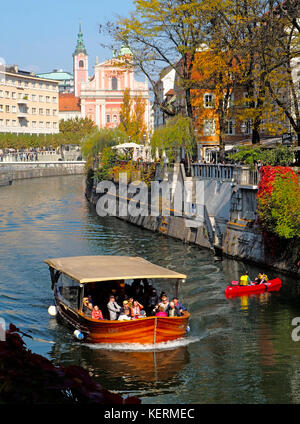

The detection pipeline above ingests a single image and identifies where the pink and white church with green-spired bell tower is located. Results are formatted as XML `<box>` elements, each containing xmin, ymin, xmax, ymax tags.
<box><xmin>73</xmin><ymin>29</ymin><xmax>151</xmax><ymax>131</ymax></box>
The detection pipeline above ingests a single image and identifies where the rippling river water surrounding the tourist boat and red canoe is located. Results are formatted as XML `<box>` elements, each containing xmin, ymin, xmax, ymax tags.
<box><xmin>0</xmin><ymin>176</ymin><xmax>300</xmax><ymax>404</ymax></box>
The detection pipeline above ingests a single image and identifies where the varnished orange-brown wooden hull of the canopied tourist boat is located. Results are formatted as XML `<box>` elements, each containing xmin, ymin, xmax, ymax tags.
<box><xmin>56</xmin><ymin>298</ymin><xmax>190</xmax><ymax>344</ymax></box>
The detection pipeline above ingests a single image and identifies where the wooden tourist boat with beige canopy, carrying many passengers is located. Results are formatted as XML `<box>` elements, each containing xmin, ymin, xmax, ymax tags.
<box><xmin>45</xmin><ymin>256</ymin><xmax>190</xmax><ymax>344</ymax></box>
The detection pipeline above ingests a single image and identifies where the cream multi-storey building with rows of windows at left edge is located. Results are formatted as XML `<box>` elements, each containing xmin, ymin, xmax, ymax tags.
<box><xmin>0</xmin><ymin>66</ymin><xmax>59</xmax><ymax>134</ymax></box>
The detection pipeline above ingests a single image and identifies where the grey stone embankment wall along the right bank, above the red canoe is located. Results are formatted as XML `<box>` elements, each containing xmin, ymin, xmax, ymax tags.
<box><xmin>86</xmin><ymin>164</ymin><xmax>300</xmax><ymax>275</ymax></box>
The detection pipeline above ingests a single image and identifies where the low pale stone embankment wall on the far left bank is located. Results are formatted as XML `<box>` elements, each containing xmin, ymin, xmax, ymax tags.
<box><xmin>0</xmin><ymin>161</ymin><xmax>85</xmax><ymax>185</ymax></box>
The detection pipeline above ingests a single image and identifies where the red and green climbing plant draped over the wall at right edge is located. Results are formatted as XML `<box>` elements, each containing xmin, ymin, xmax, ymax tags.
<box><xmin>257</xmin><ymin>166</ymin><xmax>300</xmax><ymax>239</ymax></box>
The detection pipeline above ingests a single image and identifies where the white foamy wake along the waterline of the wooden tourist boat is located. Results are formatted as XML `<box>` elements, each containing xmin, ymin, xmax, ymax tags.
<box><xmin>84</xmin><ymin>337</ymin><xmax>200</xmax><ymax>352</ymax></box>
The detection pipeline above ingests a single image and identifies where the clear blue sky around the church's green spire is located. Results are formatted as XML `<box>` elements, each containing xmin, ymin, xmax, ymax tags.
<box><xmin>0</xmin><ymin>0</ymin><xmax>134</xmax><ymax>73</ymax></box>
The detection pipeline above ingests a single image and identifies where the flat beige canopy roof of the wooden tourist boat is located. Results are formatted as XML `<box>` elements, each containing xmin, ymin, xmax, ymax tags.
<box><xmin>44</xmin><ymin>255</ymin><xmax>186</xmax><ymax>283</ymax></box>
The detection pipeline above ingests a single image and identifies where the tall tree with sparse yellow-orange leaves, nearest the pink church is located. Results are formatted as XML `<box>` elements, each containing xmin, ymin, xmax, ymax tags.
<box><xmin>106</xmin><ymin>0</ymin><xmax>210</xmax><ymax>118</ymax></box>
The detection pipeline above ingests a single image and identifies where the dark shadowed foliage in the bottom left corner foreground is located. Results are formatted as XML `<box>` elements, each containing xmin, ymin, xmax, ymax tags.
<box><xmin>0</xmin><ymin>324</ymin><xmax>140</xmax><ymax>404</ymax></box>
